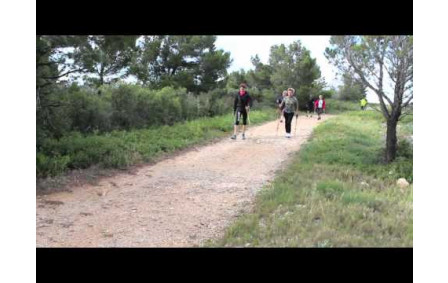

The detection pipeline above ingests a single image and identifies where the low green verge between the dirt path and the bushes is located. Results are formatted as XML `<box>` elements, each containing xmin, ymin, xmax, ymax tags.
<box><xmin>36</xmin><ymin>109</ymin><xmax>275</xmax><ymax>178</ymax></box>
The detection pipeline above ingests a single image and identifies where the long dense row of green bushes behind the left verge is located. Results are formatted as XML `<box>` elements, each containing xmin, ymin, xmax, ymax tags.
<box><xmin>36</xmin><ymin>84</ymin><xmax>243</xmax><ymax>140</ymax></box>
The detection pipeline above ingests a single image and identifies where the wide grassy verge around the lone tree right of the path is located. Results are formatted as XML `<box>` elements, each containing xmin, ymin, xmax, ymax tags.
<box><xmin>205</xmin><ymin>111</ymin><xmax>413</xmax><ymax>247</ymax></box>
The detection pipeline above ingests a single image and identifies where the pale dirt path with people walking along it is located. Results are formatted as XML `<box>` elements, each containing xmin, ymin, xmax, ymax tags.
<box><xmin>36</xmin><ymin>116</ymin><xmax>329</xmax><ymax>247</ymax></box>
